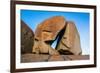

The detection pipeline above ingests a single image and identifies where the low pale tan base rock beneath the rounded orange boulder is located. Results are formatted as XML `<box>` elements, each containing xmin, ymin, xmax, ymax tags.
<box><xmin>32</xmin><ymin>40</ymin><xmax>59</xmax><ymax>55</ymax></box>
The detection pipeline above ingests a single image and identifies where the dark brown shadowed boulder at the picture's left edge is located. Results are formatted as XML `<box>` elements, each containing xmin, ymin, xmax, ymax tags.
<box><xmin>21</xmin><ymin>21</ymin><xmax>34</xmax><ymax>54</ymax></box>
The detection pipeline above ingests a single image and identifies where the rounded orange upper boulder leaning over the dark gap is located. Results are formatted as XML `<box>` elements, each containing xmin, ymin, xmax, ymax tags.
<box><xmin>35</xmin><ymin>16</ymin><xmax>66</xmax><ymax>41</ymax></box>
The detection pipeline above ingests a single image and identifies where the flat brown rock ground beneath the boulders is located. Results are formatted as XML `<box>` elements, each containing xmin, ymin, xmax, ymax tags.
<box><xmin>21</xmin><ymin>53</ymin><xmax>89</xmax><ymax>63</ymax></box>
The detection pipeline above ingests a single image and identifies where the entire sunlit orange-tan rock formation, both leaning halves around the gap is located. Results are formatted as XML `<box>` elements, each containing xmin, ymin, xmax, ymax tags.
<box><xmin>32</xmin><ymin>16</ymin><xmax>82</xmax><ymax>55</ymax></box>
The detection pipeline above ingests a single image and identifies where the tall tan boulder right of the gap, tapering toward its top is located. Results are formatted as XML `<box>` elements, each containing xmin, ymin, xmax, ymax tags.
<box><xmin>56</xmin><ymin>22</ymin><xmax>82</xmax><ymax>55</ymax></box>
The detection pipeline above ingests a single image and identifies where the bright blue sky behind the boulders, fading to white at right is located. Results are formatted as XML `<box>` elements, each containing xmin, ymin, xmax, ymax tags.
<box><xmin>21</xmin><ymin>10</ymin><xmax>90</xmax><ymax>54</ymax></box>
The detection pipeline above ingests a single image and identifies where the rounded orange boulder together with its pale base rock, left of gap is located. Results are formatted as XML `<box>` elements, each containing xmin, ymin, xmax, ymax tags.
<box><xmin>32</xmin><ymin>16</ymin><xmax>66</xmax><ymax>55</ymax></box>
